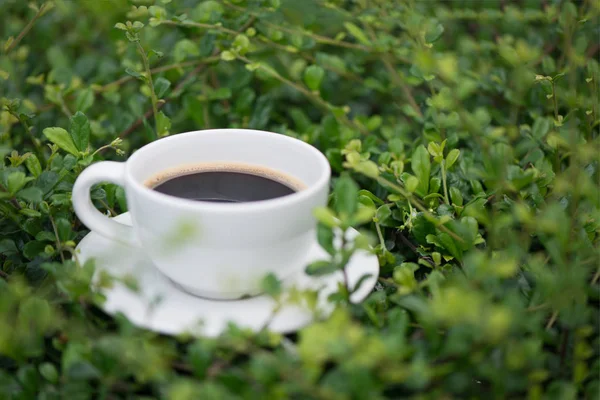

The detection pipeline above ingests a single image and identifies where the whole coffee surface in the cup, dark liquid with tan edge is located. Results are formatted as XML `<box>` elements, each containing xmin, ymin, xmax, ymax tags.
<box><xmin>146</xmin><ymin>164</ymin><xmax>302</xmax><ymax>203</ymax></box>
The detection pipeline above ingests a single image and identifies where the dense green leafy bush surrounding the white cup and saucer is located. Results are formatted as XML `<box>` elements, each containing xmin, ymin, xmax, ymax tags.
<box><xmin>0</xmin><ymin>0</ymin><xmax>600</xmax><ymax>400</ymax></box>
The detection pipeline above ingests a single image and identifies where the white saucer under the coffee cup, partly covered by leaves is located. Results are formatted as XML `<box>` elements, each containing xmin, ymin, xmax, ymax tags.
<box><xmin>77</xmin><ymin>213</ymin><xmax>379</xmax><ymax>336</ymax></box>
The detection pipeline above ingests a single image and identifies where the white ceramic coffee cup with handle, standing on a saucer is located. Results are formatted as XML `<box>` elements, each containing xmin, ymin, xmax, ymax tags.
<box><xmin>72</xmin><ymin>129</ymin><xmax>331</xmax><ymax>299</ymax></box>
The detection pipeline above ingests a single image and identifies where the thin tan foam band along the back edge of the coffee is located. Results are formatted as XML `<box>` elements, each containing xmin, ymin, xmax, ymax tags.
<box><xmin>144</xmin><ymin>162</ymin><xmax>306</xmax><ymax>192</ymax></box>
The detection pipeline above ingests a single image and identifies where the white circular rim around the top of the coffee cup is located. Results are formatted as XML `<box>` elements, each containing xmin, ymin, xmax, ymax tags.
<box><xmin>125</xmin><ymin>128</ymin><xmax>331</xmax><ymax>213</ymax></box>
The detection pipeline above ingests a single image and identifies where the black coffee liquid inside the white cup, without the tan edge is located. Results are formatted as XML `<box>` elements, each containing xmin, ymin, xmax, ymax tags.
<box><xmin>151</xmin><ymin>166</ymin><xmax>297</xmax><ymax>203</ymax></box>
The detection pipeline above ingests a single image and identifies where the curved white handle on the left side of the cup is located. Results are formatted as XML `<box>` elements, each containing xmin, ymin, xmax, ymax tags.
<box><xmin>71</xmin><ymin>161</ymin><xmax>139</xmax><ymax>246</ymax></box>
